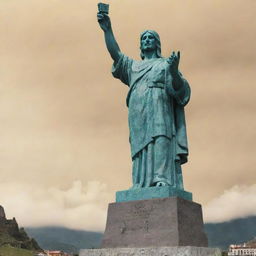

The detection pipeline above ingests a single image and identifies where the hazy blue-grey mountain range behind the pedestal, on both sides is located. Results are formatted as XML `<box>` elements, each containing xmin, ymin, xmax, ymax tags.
<box><xmin>26</xmin><ymin>217</ymin><xmax>256</xmax><ymax>252</ymax></box>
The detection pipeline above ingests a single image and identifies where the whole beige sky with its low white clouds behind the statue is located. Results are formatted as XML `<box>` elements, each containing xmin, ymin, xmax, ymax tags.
<box><xmin>0</xmin><ymin>0</ymin><xmax>256</xmax><ymax>231</ymax></box>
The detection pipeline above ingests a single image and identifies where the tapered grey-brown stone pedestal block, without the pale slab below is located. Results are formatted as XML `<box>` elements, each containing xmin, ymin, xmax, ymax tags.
<box><xmin>101</xmin><ymin>197</ymin><xmax>208</xmax><ymax>248</ymax></box>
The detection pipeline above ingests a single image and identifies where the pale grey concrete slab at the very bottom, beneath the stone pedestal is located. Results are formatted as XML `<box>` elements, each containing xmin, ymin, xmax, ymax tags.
<box><xmin>79</xmin><ymin>246</ymin><xmax>221</xmax><ymax>256</ymax></box>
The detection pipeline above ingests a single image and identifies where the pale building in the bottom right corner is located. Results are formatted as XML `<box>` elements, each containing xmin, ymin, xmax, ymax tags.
<box><xmin>228</xmin><ymin>239</ymin><xmax>256</xmax><ymax>256</ymax></box>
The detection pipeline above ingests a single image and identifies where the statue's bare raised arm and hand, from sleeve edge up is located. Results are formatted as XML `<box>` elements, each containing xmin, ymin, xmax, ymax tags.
<box><xmin>97</xmin><ymin>5</ymin><xmax>121</xmax><ymax>62</ymax></box>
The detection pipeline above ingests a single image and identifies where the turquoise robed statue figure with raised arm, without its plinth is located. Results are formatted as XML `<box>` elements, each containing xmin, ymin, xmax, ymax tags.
<box><xmin>97</xmin><ymin>4</ymin><xmax>190</xmax><ymax>190</ymax></box>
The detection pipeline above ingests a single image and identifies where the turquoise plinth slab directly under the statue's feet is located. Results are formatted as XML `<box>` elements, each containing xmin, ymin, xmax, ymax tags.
<box><xmin>116</xmin><ymin>186</ymin><xmax>192</xmax><ymax>203</ymax></box>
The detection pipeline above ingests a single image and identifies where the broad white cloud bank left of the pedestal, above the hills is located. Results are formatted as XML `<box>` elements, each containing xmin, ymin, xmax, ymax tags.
<box><xmin>0</xmin><ymin>180</ymin><xmax>111</xmax><ymax>231</ymax></box>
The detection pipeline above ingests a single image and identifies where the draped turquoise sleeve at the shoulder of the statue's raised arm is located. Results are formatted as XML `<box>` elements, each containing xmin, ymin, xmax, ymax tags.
<box><xmin>112</xmin><ymin>54</ymin><xmax>133</xmax><ymax>86</ymax></box>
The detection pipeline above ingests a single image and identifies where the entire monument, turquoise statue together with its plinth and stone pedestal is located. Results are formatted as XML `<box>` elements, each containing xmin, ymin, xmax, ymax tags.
<box><xmin>94</xmin><ymin>4</ymin><xmax>212</xmax><ymax>250</ymax></box>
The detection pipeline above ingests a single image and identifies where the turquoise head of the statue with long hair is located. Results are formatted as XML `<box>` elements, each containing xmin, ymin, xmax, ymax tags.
<box><xmin>140</xmin><ymin>30</ymin><xmax>162</xmax><ymax>59</ymax></box>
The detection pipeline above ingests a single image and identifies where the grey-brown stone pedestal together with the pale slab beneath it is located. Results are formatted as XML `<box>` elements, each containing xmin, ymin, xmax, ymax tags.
<box><xmin>79</xmin><ymin>197</ymin><xmax>216</xmax><ymax>256</ymax></box>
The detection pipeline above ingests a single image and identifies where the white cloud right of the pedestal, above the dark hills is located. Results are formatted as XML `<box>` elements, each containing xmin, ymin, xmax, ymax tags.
<box><xmin>203</xmin><ymin>184</ymin><xmax>256</xmax><ymax>222</ymax></box>
